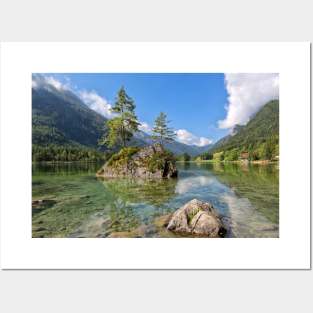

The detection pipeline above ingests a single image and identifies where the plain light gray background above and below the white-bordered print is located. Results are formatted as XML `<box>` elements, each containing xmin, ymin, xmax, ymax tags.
<box><xmin>0</xmin><ymin>0</ymin><xmax>313</xmax><ymax>313</ymax></box>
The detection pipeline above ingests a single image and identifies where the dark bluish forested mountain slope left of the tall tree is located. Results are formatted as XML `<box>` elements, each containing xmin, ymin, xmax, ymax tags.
<box><xmin>32</xmin><ymin>88</ymin><xmax>106</xmax><ymax>148</ymax></box>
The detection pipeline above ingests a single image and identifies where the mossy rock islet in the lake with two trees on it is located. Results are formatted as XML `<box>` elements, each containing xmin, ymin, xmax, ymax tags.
<box><xmin>96</xmin><ymin>144</ymin><xmax>177</xmax><ymax>179</ymax></box>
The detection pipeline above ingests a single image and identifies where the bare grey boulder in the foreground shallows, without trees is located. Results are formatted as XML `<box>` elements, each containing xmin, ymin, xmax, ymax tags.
<box><xmin>167</xmin><ymin>199</ymin><xmax>226</xmax><ymax>238</ymax></box>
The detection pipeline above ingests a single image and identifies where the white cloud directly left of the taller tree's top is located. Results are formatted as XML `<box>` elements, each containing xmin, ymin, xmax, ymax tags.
<box><xmin>79</xmin><ymin>91</ymin><xmax>116</xmax><ymax>118</ymax></box>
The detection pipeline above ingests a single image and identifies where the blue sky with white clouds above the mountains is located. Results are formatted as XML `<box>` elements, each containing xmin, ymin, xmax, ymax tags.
<box><xmin>33</xmin><ymin>73</ymin><xmax>279</xmax><ymax>146</ymax></box>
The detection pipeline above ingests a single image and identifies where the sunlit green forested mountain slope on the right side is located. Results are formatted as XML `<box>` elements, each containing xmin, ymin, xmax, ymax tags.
<box><xmin>209</xmin><ymin>100</ymin><xmax>279</xmax><ymax>153</ymax></box>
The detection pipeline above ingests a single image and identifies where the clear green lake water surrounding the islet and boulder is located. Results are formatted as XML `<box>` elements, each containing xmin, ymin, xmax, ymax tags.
<box><xmin>32</xmin><ymin>162</ymin><xmax>279</xmax><ymax>238</ymax></box>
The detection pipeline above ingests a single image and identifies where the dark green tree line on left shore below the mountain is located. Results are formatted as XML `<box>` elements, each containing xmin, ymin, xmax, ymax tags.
<box><xmin>32</xmin><ymin>144</ymin><xmax>108</xmax><ymax>162</ymax></box>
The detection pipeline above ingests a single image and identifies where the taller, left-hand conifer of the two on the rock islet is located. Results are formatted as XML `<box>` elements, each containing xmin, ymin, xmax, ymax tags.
<box><xmin>100</xmin><ymin>87</ymin><xmax>140</xmax><ymax>148</ymax></box>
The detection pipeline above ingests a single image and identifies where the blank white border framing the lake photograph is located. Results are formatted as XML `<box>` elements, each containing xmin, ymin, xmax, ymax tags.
<box><xmin>0</xmin><ymin>43</ymin><xmax>310</xmax><ymax>269</ymax></box>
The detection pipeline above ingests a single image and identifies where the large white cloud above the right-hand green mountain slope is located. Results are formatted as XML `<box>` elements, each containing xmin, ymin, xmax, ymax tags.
<box><xmin>218</xmin><ymin>74</ymin><xmax>279</xmax><ymax>128</ymax></box>
